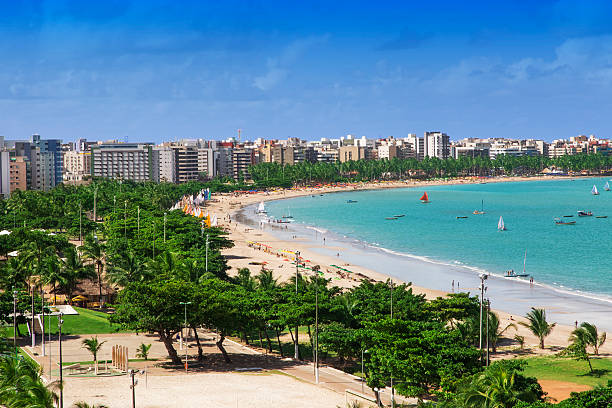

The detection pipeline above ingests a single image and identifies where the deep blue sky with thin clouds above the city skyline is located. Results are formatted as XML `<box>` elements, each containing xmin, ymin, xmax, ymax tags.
<box><xmin>0</xmin><ymin>0</ymin><xmax>612</xmax><ymax>142</ymax></box>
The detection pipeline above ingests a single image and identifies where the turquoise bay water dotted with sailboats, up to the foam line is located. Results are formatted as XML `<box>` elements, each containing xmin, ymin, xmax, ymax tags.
<box><xmin>267</xmin><ymin>178</ymin><xmax>612</xmax><ymax>298</ymax></box>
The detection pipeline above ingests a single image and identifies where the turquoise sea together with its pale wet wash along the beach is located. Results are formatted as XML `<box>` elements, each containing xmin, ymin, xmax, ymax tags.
<box><xmin>258</xmin><ymin>178</ymin><xmax>612</xmax><ymax>328</ymax></box>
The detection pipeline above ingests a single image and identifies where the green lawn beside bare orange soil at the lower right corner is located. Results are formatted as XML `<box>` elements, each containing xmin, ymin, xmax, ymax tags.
<box><xmin>525</xmin><ymin>357</ymin><xmax>612</xmax><ymax>387</ymax></box>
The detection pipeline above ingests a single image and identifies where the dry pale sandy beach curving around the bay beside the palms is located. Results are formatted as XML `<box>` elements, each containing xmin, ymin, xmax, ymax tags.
<box><xmin>207</xmin><ymin>176</ymin><xmax>612</xmax><ymax>356</ymax></box>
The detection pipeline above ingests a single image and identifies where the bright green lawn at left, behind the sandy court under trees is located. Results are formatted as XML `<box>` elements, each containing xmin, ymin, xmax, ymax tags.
<box><xmin>0</xmin><ymin>307</ymin><xmax>125</xmax><ymax>339</ymax></box>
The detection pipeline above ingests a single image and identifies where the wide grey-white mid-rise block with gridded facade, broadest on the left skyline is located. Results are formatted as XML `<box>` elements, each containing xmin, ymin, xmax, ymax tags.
<box><xmin>91</xmin><ymin>143</ymin><xmax>153</xmax><ymax>181</ymax></box>
